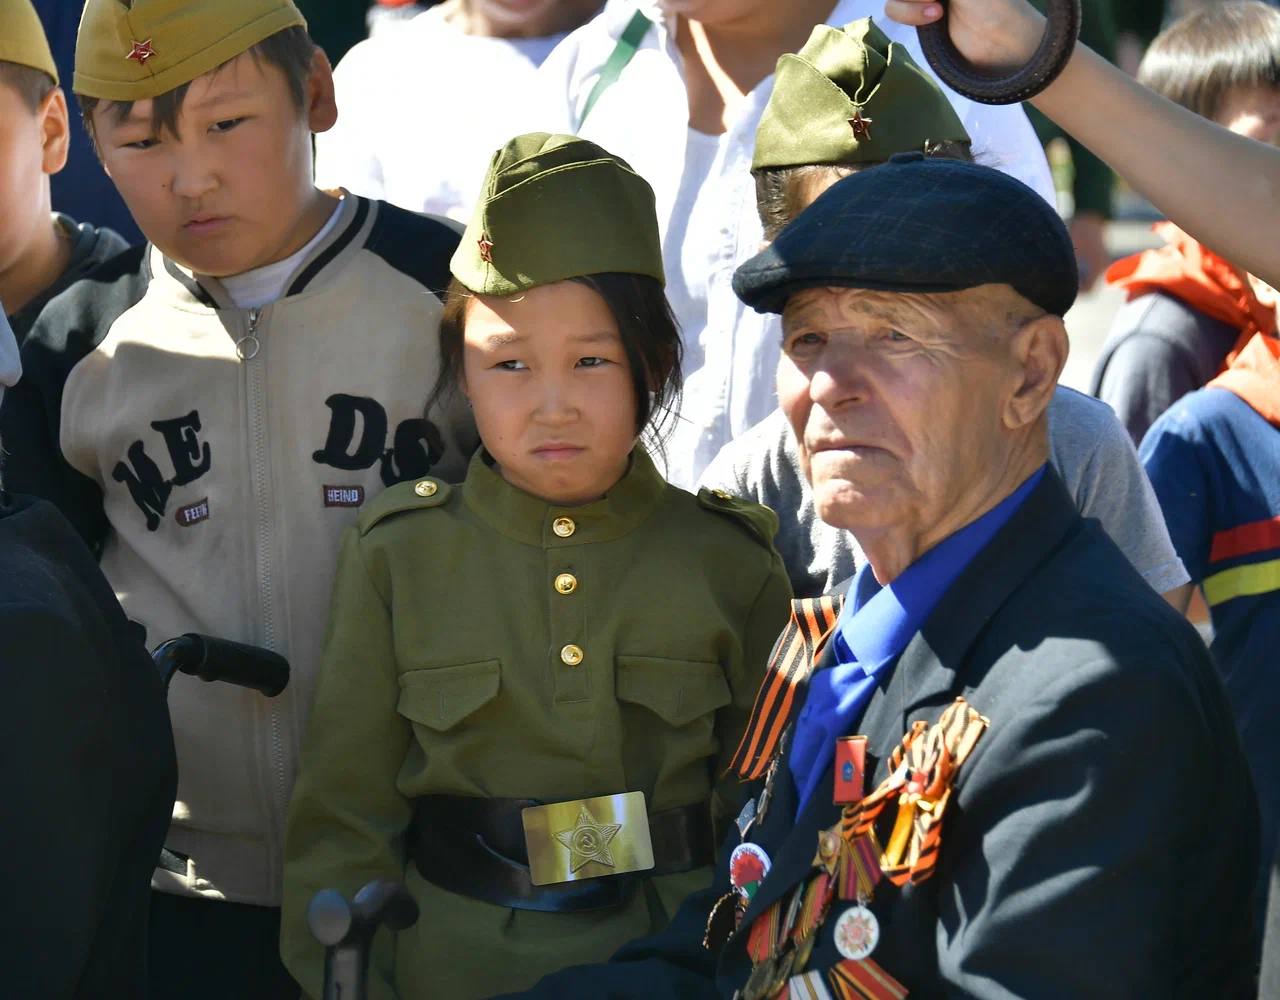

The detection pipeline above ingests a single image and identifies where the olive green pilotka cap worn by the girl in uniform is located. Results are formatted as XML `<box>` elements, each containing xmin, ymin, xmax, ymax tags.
<box><xmin>449</xmin><ymin>132</ymin><xmax>664</xmax><ymax>296</ymax></box>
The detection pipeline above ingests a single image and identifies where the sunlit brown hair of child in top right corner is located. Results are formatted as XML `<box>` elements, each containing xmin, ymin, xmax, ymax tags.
<box><xmin>1138</xmin><ymin>0</ymin><xmax>1280</xmax><ymax>119</ymax></box>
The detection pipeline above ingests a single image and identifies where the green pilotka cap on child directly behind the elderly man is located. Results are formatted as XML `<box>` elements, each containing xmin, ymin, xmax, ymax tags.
<box><xmin>751</xmin><ymin>18</ymin><xmax>969</xmax><ymax>170</ymax></box>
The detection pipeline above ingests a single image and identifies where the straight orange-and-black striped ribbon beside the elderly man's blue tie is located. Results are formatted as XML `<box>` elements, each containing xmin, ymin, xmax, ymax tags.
<box><xmin>728</xmin><ymin>595</ymin><xmax>844</xmax><ymax>781</ymax></box>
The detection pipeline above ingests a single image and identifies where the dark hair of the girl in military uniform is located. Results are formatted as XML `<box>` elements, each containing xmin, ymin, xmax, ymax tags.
<box><xmin>431</xmin><ymin>271</ymin><xmax>684</xmax><ymax>451</ymax></box>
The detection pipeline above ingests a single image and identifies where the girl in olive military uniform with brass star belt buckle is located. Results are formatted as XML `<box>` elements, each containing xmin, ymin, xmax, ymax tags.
<box><xmin>282</xmin><ymin>133</ymin><xmax>790</xmax><ymax>997</ymax></box>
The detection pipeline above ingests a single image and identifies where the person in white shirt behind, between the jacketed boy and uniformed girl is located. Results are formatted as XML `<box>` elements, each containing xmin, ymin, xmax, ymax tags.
<box><xmin>316</xmin><ymin>0</ymin><xmax>602</xmax><ymax>223</ymax></box>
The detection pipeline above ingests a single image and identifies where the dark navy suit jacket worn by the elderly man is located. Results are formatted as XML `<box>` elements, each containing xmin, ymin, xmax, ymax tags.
<box><xmin>504</xmin><ymin>471</ymin><xmax>1257</xmax><ymax>1000</ymax></box>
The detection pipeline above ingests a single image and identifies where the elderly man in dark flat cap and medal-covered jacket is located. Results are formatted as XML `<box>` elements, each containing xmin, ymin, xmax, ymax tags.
<box><xmin>504</xmin><ymin>154</ymin><xmax>1257</xmax><ymax>1000</ymax></box>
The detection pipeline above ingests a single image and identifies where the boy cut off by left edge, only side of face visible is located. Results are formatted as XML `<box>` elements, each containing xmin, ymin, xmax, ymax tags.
<box><xmin>0</xmin><ymin>0</ymin><xmax>125</xmax><ymax>343</ymax></box>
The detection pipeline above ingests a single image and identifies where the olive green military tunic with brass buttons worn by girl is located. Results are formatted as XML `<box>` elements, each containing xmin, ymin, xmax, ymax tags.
<box><xmin>282</xmin><ymin>449</ymin><xmax>790</xmax><ymax>1000</ymax></box>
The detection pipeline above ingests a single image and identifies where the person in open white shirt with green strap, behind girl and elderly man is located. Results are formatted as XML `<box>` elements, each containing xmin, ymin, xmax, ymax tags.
<box><xmin>524</xmin><ymin>0</ymin><xmax>1053</xmax><ymax>488</ymax></box>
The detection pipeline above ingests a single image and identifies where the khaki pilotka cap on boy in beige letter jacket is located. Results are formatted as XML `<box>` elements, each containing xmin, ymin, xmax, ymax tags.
<box><xmin>73</xmin><ymin>0</ymin><xmax>307</xmax><ymax>101</ymax></box>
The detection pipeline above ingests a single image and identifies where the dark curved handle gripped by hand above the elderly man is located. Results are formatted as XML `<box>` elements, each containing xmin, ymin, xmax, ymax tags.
<box><xmin>918</xmin><ymin>0</ymin><xmax>1082</xmax><ymax>104</ymax></box>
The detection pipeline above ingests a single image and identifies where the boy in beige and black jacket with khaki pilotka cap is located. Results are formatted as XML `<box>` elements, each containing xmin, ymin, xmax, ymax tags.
<box><xmin>0</xmin><ymin>0</ymin><xmax>475</xmax><ymax>999</ymax></box>
